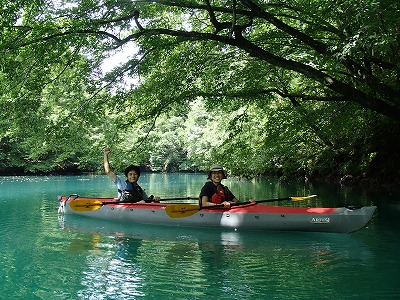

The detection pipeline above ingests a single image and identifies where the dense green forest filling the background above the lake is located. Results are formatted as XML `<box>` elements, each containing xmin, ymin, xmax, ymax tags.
<box><xmin>0</xmin><ymin>0</ymin><xmax>400</xmax><ymax>188</ymax></box>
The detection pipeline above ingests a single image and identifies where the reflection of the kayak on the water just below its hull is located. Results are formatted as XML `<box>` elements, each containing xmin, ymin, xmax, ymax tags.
<box><xmin>59</xmin><ymin>215</ymin><xmax>373</xmax><ymax>264</ymax></box>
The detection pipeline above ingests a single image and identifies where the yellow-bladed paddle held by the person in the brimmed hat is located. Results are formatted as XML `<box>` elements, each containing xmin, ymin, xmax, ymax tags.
<box><xmin>165</xmin><ymin>195</ymin><xmax>317</xmax><ymax>218</ymax></box>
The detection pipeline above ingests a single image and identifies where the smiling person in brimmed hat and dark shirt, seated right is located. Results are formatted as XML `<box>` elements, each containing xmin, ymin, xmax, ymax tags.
<box><xmin>200</xmin><ymin>165</ymin><xmax>239</xmax><ymax>207</ymax></box>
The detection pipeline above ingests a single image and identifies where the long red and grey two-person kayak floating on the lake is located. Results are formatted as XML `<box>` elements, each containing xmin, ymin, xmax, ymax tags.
<box><xmin>58</xmin><ymin>195</ymin><xmax>376</xmax><ymax>233</ymax></box>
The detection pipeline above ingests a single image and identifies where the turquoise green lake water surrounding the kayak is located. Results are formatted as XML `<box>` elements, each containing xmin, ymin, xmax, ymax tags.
<box><xmin>0</xmin><ymin>174</ymin><xmax>400</xmax><ymax>300</ymax></box>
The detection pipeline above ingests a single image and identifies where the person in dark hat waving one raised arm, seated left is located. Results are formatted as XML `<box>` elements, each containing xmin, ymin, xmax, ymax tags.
<box><xmin>104</xmin><ymin>147</ymin><xmax>160</xmax><ymax>203</ymax></box>
